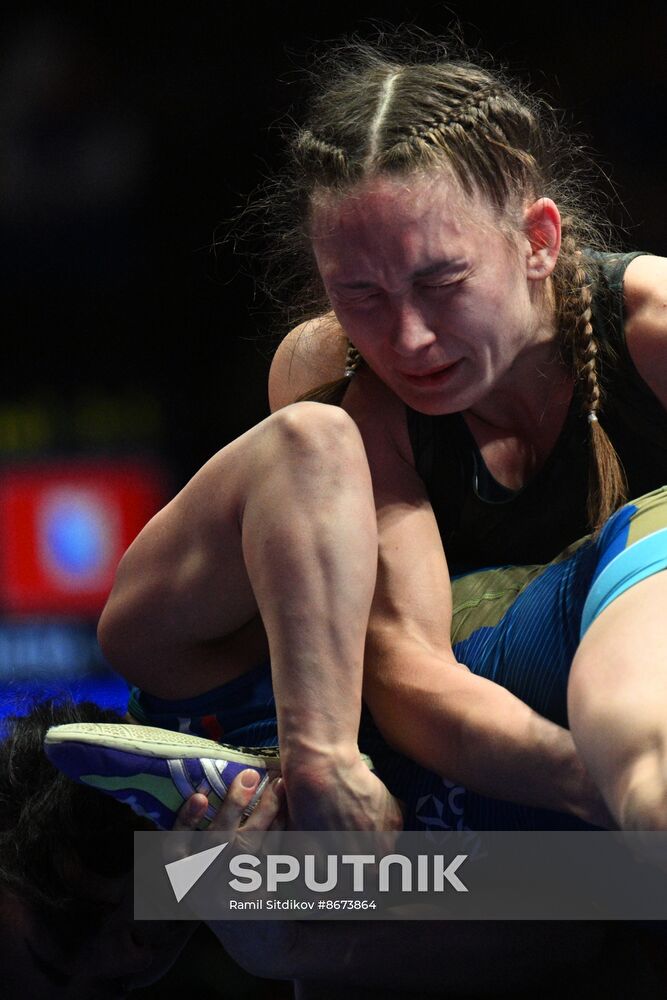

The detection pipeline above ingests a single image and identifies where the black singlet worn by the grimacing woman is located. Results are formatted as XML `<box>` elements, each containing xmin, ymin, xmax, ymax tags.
<box><xmin>407</xmin><ymin>253</ymin><xmax>667</xmax><ymax>573</ymax></box>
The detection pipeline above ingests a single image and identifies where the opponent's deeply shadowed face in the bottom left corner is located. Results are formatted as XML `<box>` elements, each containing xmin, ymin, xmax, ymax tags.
<box><xmin>0</xmin><ymin>879</ymin><xmax>194</xmax><ymax>1000</ymax></box>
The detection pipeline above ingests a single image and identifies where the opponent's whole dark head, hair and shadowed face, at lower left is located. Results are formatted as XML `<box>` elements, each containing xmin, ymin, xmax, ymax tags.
<box><xmin>0</xmin><ymin>702</ymin><xmax>185</xmax><ymax>1000</ymax></box>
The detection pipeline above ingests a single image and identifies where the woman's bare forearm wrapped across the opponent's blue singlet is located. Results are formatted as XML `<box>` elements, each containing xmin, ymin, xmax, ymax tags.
<box><xmin>365</xmin><ymin>645</ymin><xmax>598</xmax><ymax>818</ymax></box>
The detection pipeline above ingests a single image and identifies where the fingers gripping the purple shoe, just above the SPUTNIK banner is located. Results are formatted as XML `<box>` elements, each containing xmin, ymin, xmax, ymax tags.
<box><xmin>173</xmin><ymin>768</ymin><xmax>287</xmax><ymax>834</ymax></box>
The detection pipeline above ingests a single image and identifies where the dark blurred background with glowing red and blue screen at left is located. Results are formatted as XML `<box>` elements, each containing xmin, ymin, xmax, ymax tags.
<box><xmin>0</xmin><ymin>0</ymin><xmax>667</xmax><ymax>998</ymax></box>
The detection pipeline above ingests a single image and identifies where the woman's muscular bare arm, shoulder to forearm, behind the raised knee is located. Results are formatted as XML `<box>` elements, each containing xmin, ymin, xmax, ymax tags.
<box><xmin>272</xmin><ymin>325</ymin><xmax>612</xmax><ymax>816</ymax></box>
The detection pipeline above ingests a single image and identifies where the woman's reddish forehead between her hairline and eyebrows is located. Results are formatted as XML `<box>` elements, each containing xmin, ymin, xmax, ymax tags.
<box><xmin>311</xmin><ymin>172</ymin><xmax>500</xmax><ymax>277</ymax></box>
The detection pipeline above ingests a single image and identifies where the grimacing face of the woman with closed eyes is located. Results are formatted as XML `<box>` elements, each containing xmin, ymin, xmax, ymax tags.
<box><xmin>311</xmin><ymin>173</ymin><xmax>555</xmax><ymax>414</ymax></box>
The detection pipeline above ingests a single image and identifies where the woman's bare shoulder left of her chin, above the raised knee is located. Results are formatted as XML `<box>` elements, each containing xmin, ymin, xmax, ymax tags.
<box><xmin>269</xmin><ymin>313</ymin><xmax>347</xmax><ymax>411</ymax></box>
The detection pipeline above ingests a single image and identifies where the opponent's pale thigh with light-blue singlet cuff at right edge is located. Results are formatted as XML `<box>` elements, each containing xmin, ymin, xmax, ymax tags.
<box><xmin>568</xmin><ymin>488</ymin><xmax>667</xmax><ymax>830</ymax></box>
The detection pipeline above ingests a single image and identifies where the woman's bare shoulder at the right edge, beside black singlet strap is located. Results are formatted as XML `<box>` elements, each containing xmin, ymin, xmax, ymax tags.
<box><xmin>623</xmin><ymin>256</ymin><xmax>667</xmax><ymax>406</ymax></box>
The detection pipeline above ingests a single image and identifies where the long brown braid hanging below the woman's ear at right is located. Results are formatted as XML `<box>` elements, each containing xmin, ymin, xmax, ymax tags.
<box><xmin>561</xmin><ymin>234</ymin><xmax>627</xmax><ymax>532</ymax></box>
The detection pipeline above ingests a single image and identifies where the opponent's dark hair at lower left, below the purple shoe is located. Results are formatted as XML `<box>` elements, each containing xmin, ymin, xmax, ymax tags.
<box><xmin>0</xmin><ymin>700</ymin><xmax>152</xmax><ymax>918</ymax></box>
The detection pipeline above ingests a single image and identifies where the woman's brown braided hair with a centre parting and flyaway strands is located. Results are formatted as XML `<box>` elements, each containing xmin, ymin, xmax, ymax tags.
<box><xmin>256</xmin><ymin>31</ymin><xmax>625</xmax><ymax>528</ymax></box>
